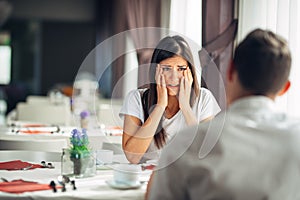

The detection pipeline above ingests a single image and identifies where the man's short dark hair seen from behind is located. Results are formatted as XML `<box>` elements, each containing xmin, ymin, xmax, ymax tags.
<box><xmin>233</xmin><ymin>29</ymin><xmax>292</xmax><ymax>95</ymax></box>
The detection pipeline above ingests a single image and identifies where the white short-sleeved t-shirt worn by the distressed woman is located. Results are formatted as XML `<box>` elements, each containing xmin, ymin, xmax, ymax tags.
<box><xmin>119</xmin><ymin>88</ymin><xmax>221</xmax><ymax>161</ymax></box>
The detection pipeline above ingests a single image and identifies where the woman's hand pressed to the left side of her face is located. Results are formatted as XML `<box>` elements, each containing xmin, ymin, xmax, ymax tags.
<box><xmin>155</xmin><ymin>64</ymin><xmax>168</xmax><ymax>108</ymax></box>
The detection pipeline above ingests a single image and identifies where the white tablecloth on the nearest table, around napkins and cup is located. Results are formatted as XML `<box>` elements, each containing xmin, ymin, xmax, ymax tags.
<box><xmin>0</xmin><ymin>157</ymin><xmax>151</xmax><ymax>200</ymax></box>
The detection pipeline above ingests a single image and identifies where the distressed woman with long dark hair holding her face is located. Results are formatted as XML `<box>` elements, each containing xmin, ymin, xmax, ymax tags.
<box><xmin>120</xmin><ymin>36</ymin><xmax>220</xmax><ymax>163</ymax></box>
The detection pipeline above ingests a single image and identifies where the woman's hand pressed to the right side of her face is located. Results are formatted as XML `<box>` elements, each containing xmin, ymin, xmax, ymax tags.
<box><xmin>178</xmin><ymin>68</ymin><xmax>193</xmax><ymax>109</ymax></box>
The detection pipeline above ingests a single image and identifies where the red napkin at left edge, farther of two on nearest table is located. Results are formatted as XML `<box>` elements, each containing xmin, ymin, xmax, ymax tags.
<box><xmin>0</xmin><ymin>160</ymin><xmax>43</xmax><ymax>170</ymax></box>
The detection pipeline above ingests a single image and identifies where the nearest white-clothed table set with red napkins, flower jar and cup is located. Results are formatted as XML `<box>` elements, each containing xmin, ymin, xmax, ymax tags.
<box><xmin>0</xmin><ymin>129</ymin><xmax>152</xmax><ymax>197</ymax></box>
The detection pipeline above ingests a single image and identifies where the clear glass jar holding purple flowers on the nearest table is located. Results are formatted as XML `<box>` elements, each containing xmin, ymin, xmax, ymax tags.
<box><xmin>61</xmin><ymin>149</ymin><xmax>96</xmax><ymax>178</ymax></box>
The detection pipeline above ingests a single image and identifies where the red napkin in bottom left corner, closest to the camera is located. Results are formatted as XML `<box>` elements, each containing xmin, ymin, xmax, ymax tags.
<box><xmin>0</xmin><ymin>179</ymin><xmax>52</xmax><ymax>193</ymax></box>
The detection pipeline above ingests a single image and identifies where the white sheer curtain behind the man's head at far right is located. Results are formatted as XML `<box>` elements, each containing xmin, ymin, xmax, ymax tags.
<box><xmin>238</xmin><ymin>0</ymin><xmax>300</xmax><ymax>118</ymax></box>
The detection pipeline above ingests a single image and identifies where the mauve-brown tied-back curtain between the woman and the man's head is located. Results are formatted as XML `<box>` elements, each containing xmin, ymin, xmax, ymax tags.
<box><xmin>199</xmin><ymin>0</ymin><xmax>237</xmax><ymax>109</ymax></box>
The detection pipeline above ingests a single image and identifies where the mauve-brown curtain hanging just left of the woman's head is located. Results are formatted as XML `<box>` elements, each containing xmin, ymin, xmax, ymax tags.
<box><xmin>124</xmin><ymin>0</ymin><xmax>161</xmax><ymax>86</ymax></box>
